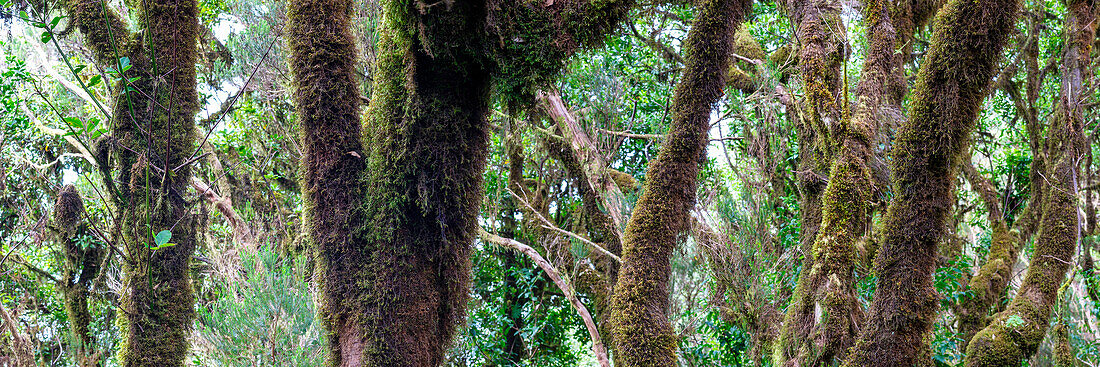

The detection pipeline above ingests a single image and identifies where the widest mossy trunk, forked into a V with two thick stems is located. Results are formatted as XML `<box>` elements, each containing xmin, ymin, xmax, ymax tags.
<box><xmin>289</xmin><ymin>1</ymin><xmax>488</xmax><ymax>366</ymax></box>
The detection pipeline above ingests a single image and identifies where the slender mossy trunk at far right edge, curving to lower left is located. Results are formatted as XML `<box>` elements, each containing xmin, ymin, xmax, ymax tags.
<box><xmin>966</xmin><ymin>0</ymin><xmax>1097</xmax><ymax>367</ymax></box>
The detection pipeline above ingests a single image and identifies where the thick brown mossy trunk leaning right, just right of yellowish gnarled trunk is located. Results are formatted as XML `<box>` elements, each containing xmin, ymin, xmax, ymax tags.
<box><xmin>845</xmin><ymin>0</ymin><xmax>1019</xmax><ymax>366</ymax></box>
